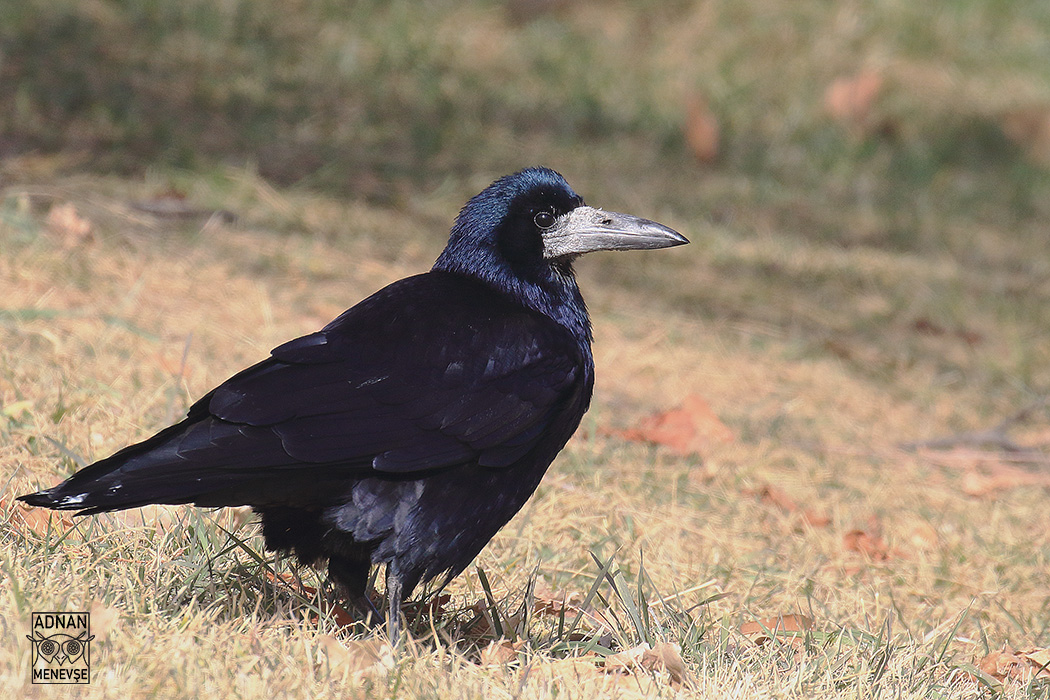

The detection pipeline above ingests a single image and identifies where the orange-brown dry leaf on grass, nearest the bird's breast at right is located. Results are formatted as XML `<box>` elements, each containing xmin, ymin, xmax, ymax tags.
<box><xmin>607</xmin><ymin>394</ymin><xmax>734</xmax><ymax>457</ymax></box>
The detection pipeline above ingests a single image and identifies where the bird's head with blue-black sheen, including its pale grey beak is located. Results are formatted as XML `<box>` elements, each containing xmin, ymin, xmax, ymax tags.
<box><xmin>435</xmin><ymin>168</ymin><xmax>689</xmax><ymax>283</ymax></box>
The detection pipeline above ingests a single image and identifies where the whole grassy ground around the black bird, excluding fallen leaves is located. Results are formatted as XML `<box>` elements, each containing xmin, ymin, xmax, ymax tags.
<box><xmin>0</xmin><ymin>0</ymin><xmax>1050</xmax><ymax>698</ymax></box>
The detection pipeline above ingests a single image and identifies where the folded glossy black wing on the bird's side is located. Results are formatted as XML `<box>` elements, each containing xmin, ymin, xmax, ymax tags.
<box><xmin>201</xmin><ymin>273</ymin><xmax>589</xmax><ymax>472</ymax></box>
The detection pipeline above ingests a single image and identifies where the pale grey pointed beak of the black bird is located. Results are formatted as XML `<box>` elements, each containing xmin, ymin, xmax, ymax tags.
<box><xmin>543</xmin><ymin>207</ymin><xmax>689</xmax><ymax>259</ymax></box>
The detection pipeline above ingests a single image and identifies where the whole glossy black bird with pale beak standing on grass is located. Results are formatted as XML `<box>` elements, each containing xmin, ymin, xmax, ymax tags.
<box><xmin>20</xmin><ymin>168</ymin><xmax>688</xmax><ymax>636</ymax></box>
